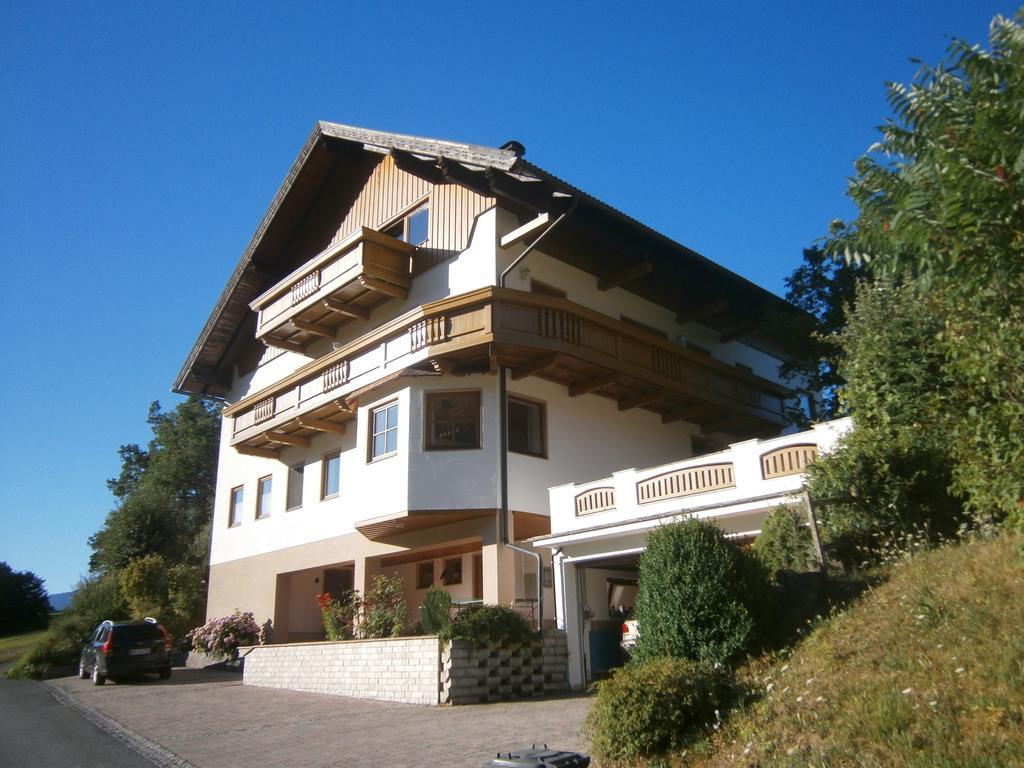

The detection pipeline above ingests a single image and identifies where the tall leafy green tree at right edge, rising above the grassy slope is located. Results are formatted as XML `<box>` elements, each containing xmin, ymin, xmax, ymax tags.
<box><xmin>828</xmin><ymin>11</ymin><xmax>1024</xmax><ymax>517</ymax></box>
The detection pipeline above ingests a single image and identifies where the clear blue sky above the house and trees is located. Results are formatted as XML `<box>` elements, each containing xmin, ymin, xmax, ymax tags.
<box><xmin>0</xmin><ymin>0</ymin><xmax>1016</xmax><ymax>593</ymax></box>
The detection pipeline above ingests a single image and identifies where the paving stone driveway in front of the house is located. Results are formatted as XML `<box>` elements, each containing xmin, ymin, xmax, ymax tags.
<box><xmin>50</xmin><ymin>669</ymin><xmax>589</xmax><ymax>768</ymax></box>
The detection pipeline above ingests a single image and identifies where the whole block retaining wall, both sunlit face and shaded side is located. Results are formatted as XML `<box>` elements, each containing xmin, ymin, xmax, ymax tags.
<box><xmin>241</xmin><ymin>634</ymin><xmax>568</xmax><ymax>705</ymax></box>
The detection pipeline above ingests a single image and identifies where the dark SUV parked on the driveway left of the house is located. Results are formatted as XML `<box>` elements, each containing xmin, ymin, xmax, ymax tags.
<box><xmin>78</xmin><ymin>618</ymin><xmax>171</xmax><ymax>685</ymax></box>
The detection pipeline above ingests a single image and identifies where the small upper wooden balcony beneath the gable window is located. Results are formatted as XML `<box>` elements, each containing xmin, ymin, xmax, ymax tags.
<box><xmin>249</xmin><ymin>227</ymin><xmax>416</xmax><ymax>352</ymax></box>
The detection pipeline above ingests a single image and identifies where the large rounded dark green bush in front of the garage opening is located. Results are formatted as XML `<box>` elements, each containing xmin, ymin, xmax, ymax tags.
<box><xmin>634</xmin><ymin>519</ymin><xmax>772</xmax><ymax>663</ymax></box>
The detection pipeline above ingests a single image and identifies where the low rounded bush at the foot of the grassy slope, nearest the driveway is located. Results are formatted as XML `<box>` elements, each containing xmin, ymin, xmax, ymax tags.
<box><xmin>584</xmin><ymin>658</ymin><xmax>733</xmax><ymax>766</ymax></box>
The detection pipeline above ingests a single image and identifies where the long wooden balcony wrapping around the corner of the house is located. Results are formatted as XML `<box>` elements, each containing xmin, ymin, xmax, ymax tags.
<box><xmin>224</xmin><ymin>288</ymin><xmax>788</xmax><ymax>456</ymax></box>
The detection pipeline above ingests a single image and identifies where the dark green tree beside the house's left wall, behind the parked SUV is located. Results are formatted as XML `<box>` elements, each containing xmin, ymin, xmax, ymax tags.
<box><xmin>89</xmin><ymin>397</ymin><xmax>220</xmax><ymax>572</ymax></box>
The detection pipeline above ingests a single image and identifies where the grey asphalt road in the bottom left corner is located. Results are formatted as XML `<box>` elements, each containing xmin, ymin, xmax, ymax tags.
<box><xmin>0</xmin><ymin>679</ymin><xmax>153</xmax><ymax>768</ymax></box>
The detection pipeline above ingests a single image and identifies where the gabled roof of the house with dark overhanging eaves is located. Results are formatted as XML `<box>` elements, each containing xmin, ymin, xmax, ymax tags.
<box><xmin>173</xmin><ymin>122</ymin><xmax>785</xmax><ymax>395</ymax></box>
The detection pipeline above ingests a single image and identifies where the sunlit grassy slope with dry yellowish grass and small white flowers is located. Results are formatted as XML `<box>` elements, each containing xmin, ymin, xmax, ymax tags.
<box><xmin>692</xmin><ymin>537</ymin><xmax>1024</xmax><ymax>768</ymax></box>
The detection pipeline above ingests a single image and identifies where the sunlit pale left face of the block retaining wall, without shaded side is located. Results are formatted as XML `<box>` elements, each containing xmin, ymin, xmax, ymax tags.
<box><xmin>241</xmin><ymin>637</ymin><xmax>438</xmax><ymax>705</ymax></box>
